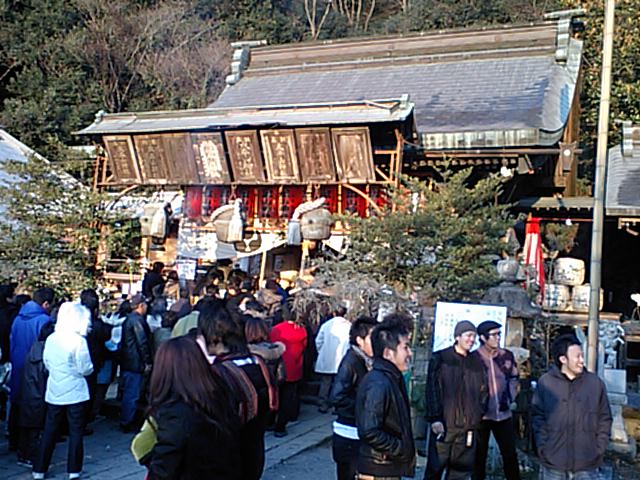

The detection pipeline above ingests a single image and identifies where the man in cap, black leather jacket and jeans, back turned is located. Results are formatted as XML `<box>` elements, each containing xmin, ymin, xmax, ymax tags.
<box><xmin>119</xmin><ymin>294</ymin><xmax>153</xmax><ymax>431</ymax></box>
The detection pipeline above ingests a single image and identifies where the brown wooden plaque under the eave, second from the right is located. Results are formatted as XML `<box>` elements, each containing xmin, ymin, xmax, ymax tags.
<box><xmin>296</xmin><ymin>128</ymin><xmax>336</xmax><ymax>183</ymax></box>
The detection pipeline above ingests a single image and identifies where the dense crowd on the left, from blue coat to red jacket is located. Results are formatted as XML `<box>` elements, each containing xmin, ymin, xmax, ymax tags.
<box><xmin>0</xmin><ymin>263</ymin><xmax>307</xmax><ymax>480</ymax></box>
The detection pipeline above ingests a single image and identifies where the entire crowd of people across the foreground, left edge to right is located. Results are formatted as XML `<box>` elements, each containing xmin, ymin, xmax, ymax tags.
<box><xmin>0</xmin><ymin>264</ymin><xmax>611</xmax><ymax>480</ymax></box>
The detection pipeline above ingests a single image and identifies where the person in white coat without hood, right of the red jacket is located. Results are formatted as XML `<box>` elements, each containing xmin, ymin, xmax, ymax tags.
<box><xmin>315</xmin><ymin>307</ymin><xmax>351</xmax><ymax>413</ymax></box>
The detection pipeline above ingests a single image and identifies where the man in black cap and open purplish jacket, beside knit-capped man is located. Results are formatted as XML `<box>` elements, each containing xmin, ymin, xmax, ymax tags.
<box><xmin>473</xmin><ymin>320</ymin><xmax>520</xmax><ymax>480</ymax></box>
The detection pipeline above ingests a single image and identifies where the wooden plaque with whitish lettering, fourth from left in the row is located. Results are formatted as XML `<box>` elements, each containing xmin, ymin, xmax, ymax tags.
<box><xmin>191</xmin><ymin>132</ymin><xmax>231</xmax><ymax>184</ymax></box>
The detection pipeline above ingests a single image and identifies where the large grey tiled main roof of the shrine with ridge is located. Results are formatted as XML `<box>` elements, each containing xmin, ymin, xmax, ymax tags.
<box><xmin>211</xmin><ymin>24</ymin><xmax>582</xmax><ymax>148</ymax></box>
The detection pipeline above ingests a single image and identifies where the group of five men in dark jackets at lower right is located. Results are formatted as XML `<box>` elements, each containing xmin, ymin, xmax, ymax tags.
<box><xmin>331</xmin><ymin>314</ymin><xmax>612</xmax><ymax>480</ymax></box>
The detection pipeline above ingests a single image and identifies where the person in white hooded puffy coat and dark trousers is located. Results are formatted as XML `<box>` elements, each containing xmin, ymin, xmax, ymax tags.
<box><xmin>33</xmin><ymin>302</ymin><xmax>93</xmax><ymax>480</ymax></box>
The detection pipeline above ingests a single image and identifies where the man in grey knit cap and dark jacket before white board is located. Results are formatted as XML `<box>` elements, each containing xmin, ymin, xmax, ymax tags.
<box><xmin>424</xmin><ymin>320</ymin><xmax>487</xmax><ymax>480</ymax></box>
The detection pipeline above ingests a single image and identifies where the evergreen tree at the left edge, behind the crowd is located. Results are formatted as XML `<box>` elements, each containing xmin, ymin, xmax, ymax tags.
<box><xmin>0</xmin><ymin>157</ymin><xmax>121</xmax><ymax>293</ymax></box>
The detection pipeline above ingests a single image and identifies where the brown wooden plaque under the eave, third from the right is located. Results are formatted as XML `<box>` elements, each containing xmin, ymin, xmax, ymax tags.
<box><xmin>260</xmin><ymin>130</ymin><xmax>300</xmax><ymax>183</ymax></box>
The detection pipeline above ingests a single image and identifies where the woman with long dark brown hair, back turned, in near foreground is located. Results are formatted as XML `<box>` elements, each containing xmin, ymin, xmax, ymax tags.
<box><xmin>147</xmin><ymin>335</ymin><xmax>240</xmax><ymax>480</ymax></box>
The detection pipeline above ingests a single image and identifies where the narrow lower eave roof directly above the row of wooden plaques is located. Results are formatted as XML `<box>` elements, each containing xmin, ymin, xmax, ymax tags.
<box><xmin>76</xmin><ymin>97</ymin><xmax>413</xmax><ymax>135</ymax></box>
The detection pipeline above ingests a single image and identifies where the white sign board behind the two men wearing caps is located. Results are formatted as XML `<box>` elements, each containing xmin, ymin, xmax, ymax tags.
<box><xmin>433</xmin><ymin>302</ymin><xmax>507</xmax><ymax>352</ymax></box>
